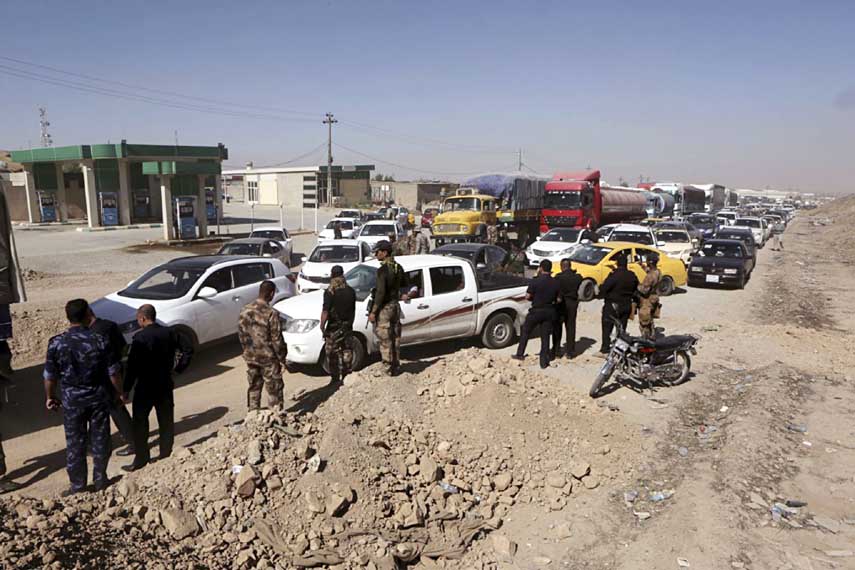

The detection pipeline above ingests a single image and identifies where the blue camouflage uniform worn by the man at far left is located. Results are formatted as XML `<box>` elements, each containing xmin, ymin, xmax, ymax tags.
<box><xmin>44</xmin><ymin>326</ymin><xmax>121</xmax><ymax>491</ymax></box>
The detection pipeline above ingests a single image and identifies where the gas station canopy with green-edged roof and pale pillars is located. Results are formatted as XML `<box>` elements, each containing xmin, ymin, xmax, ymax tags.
<box><xmin>10</xmin><ymin>140</ymin><xmax>228</xmax><ymax>240</ymax></box>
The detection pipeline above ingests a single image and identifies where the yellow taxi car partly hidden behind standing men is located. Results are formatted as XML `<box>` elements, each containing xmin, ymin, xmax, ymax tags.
<box><xmin>552</xmin><ymin>241</ymin><xmax>688</xmax><ymax>301</ymax></box>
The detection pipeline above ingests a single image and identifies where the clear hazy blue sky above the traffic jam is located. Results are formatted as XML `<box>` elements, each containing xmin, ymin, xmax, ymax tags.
<box><xmin>0</xmin><ymin>0</ymin><xmax>855</xmax><ymax>193</ymax></box>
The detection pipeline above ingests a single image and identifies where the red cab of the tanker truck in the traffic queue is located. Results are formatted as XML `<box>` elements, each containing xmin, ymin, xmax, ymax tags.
<box><xmin>540</xmin><ymin>170</ymin><xmax>602</xmax><ymax>233</ymax></box>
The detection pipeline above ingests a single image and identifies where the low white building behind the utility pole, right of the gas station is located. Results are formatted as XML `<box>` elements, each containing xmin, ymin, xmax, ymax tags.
<box><xmin>222</xmin><ymin>164</ymin><xmax>374</xmax><ymax>209</ymax></box>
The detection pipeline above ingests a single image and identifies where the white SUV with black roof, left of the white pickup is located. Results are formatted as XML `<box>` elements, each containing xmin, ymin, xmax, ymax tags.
<box><xmin>92</xmin><ymin>255</ymin><xmax>296</xmax><ymax>346</ymax></box>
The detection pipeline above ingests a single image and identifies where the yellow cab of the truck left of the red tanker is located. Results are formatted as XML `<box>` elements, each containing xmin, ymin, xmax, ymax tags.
<box><xmin>431</xmin><ymin>188</ymin><xmax>496</xmax><ymax>247</ymax></box>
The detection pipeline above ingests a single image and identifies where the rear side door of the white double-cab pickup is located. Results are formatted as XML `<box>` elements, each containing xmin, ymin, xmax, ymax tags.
<box><xmin>428</xmin><ymin>265</ymin><xmax>478</xmax><ymax>340</ymax></box>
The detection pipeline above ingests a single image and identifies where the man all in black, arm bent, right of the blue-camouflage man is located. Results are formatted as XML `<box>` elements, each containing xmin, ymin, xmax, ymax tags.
<box><xmin>123</xmin><ymin>305</ymin><xmax>193</xmax><ymax>471</ymax></box>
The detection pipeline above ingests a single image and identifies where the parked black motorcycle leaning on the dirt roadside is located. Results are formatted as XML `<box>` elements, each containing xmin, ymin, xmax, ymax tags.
<box><xmin>590</xmin><ymin>320</ymin><xmax>698</xmax><ymax>398</ymax></box>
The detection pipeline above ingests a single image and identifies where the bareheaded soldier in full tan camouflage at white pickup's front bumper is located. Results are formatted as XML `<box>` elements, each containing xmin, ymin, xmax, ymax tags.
<box><xmin>238</xmin><ymin>281</ymin><xmax>288</xmax><ymax>410</ymax></box>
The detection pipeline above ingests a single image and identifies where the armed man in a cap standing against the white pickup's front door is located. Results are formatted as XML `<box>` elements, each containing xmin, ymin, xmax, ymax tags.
<box><xmin>368</xmin><ymin>240</ymin><xmax>407</xmax><ymax>376</ymax></box>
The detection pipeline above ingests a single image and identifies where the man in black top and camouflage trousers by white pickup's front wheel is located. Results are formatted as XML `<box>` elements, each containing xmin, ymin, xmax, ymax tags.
<box><xmin>321</xmin><ymin>265</ymin><xmax>356</xmax><ymax>383</ymax></box>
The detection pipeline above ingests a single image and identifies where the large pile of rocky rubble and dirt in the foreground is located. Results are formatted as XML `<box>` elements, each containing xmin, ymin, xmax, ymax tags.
<box><xmin>0</xmin><ymin>349</ymin><xmax>633</xmax><ymax>570</ymax></box>
